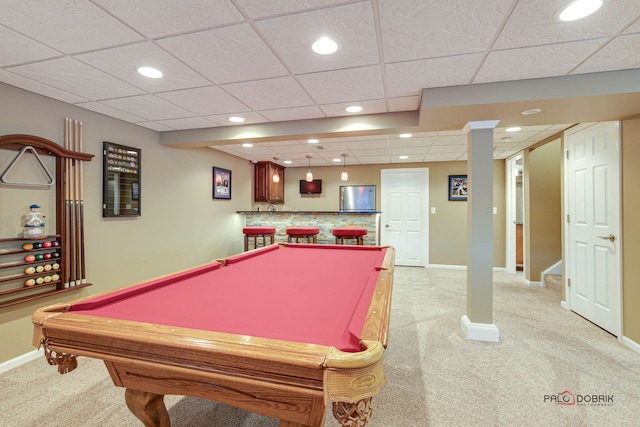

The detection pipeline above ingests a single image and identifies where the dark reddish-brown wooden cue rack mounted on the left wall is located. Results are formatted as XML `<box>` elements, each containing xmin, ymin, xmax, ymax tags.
<box><xmin>0</xmin><ymin>134</ymin><xmax>94</xmax><ymax>308</ymax></box>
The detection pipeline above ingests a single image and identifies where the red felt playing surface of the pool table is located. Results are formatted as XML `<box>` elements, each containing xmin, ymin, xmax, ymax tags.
<box><xmin>71</xmin><ymin>244</ymin><xmax>386</xmax><ymax>351</ymax></box>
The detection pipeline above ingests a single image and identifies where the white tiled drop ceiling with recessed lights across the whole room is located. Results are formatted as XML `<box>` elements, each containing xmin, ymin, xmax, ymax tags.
<box><xmin>0</xmin><ymin>0</ymin><xmax>640</xmax><ymax>166</ymax></box>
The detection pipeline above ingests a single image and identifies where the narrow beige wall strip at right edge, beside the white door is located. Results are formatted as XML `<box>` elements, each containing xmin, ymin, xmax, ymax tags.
<box><xmin>622</xmin><ymin>117</ymin><xmax>640</xmax><ymax>343</ymax></box>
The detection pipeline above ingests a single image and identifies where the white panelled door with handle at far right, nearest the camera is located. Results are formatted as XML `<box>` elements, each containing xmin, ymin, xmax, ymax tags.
<box><xmin>565</xmin><ymin>122</ymin><xmax>621</xmax><ymax>336</ymax></box>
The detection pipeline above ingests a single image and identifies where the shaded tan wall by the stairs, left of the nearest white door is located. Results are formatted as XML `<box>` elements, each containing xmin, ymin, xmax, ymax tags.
<box><xmin>525</xmin><ymin>138</ymin><xmax>562</xmax><ymax>282</ymax></box>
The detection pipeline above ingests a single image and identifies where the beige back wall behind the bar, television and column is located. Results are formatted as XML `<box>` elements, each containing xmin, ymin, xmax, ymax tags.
<box><xmin>252</xmin><ymin>160</ymin><xmax>506</xmax><ymax>267</ymax></box>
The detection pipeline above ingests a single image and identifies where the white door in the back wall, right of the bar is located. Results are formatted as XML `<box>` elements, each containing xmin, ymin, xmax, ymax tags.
<box><xmin>380</xmin><ymin>168</ymin><xmax>429</xmax><ymax>267</ymax></box>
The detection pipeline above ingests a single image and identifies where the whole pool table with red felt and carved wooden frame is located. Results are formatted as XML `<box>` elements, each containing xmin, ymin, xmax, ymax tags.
<box><xmin>33</xmin><ymin>243</ymin><xmax>395</xmax><ymax>427</ymax></box>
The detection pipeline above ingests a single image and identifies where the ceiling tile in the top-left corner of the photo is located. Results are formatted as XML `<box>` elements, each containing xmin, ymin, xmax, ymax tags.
<box><xmin>0</xmin><ymin>0</ymin><xmax>142</xmax><ymax>54</ymax></box>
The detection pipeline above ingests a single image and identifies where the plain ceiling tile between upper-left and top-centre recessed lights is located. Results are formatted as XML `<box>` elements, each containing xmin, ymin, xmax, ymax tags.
<box><xmin>157</xmin><ymin>24</ymin><xmax>287</xmax><ymax>84</ymax></box>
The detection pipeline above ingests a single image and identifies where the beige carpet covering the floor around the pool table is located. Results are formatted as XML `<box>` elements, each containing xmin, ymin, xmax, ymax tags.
<box><xmin>0</xmin><ymin>267</ymin><xmax>640</xmax><ymax>427</ymax></box>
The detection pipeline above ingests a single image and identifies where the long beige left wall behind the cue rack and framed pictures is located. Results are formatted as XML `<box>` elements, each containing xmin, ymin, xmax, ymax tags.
<box><xmin>0</xmin><ymin>84</ymin><xmax>252</xmax><ymax>363</ymax></box>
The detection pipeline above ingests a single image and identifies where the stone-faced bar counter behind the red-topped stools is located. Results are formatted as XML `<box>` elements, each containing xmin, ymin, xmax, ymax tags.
<box><xmin>237</xmin><ymin>211</ymin><xmax>380</xmax><ymax>245</ymax></box>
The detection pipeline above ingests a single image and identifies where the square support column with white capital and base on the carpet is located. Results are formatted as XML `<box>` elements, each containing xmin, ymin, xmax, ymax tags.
<box><xmin>461</xmin><ymin>120</ymin><xmax>500</xmax><ymax>342</ymax></box>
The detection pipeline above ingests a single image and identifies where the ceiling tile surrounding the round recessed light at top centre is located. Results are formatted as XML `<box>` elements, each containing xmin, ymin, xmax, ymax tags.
<box><xmin>256</xmin><ymin>2</ymin><xmax>380</xmax><ymax>74</ymax></box>
